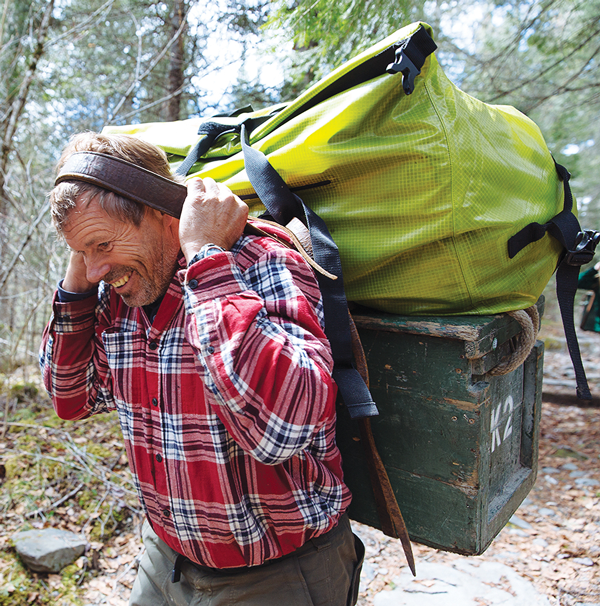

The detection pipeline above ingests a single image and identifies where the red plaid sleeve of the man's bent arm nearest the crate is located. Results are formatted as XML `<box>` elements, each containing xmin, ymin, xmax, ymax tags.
<box><xmin>184</xmin><ymin>238</ymin><xmax>336</xmax><ymax>465</ymax></box>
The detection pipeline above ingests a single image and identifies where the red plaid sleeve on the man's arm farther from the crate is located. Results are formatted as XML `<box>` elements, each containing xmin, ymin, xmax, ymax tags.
<box><xmin>40</xmin><ymin>290</ymin><xmax>115</xmax><ymax>420</ymax></box>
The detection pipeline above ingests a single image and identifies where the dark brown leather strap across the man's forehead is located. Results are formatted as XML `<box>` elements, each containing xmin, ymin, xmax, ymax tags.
<box><xmin>54</xmin><ymin>152</ymin><xmax>187</xmax><ymax>219</ymax></box>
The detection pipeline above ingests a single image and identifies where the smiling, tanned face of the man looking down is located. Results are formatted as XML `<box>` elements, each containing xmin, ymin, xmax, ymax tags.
<box><xmin>63</xmin><ymin>199</ymin><xmax>179</xmax><ymax>307</ymax></box>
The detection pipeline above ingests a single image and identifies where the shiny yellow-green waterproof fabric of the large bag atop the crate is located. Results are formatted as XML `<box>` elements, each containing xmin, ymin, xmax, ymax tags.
<box><xmin>104</xmin><ymin>23</ymin><xmax>563</xmax><ymax>315</ymax></box>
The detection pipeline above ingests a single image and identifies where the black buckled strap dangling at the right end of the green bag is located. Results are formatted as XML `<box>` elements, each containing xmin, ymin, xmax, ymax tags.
<box><xmin>508</xmin><ymin>162</ymin><xmax>600</xmax><ymax>400</ymax></box>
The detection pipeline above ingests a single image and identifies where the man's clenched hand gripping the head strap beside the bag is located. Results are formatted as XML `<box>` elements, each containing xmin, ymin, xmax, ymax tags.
<box><xmin>179</xmin><ymin>178</ymin><xmax>248</xmax><ymax>263</ymax></box>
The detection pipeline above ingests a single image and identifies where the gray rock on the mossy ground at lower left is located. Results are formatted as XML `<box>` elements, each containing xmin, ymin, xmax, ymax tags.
<box><xmin>12</xmin><ymin>528</ymin><xmax>87</xmax><ymax>573</ymax></box>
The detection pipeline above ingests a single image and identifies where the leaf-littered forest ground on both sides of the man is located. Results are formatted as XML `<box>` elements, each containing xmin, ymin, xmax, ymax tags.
<box><xmin>0</xmin><ymin>352</ymin><xmax>600</xmax><ymax>606</ymax></box>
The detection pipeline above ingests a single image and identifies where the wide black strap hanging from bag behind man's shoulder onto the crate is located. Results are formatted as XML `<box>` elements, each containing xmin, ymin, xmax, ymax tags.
<box><xmin>241</xmin><ymin>126</ymin><xmax>379</xmax><ymax>419</ymax></box>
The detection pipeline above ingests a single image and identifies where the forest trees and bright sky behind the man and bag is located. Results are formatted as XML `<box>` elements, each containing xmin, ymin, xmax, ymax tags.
<box><xmin>0</xmin><ymin>0</ymin><xmax>600</xmax><ymax>374</ymax></box>
